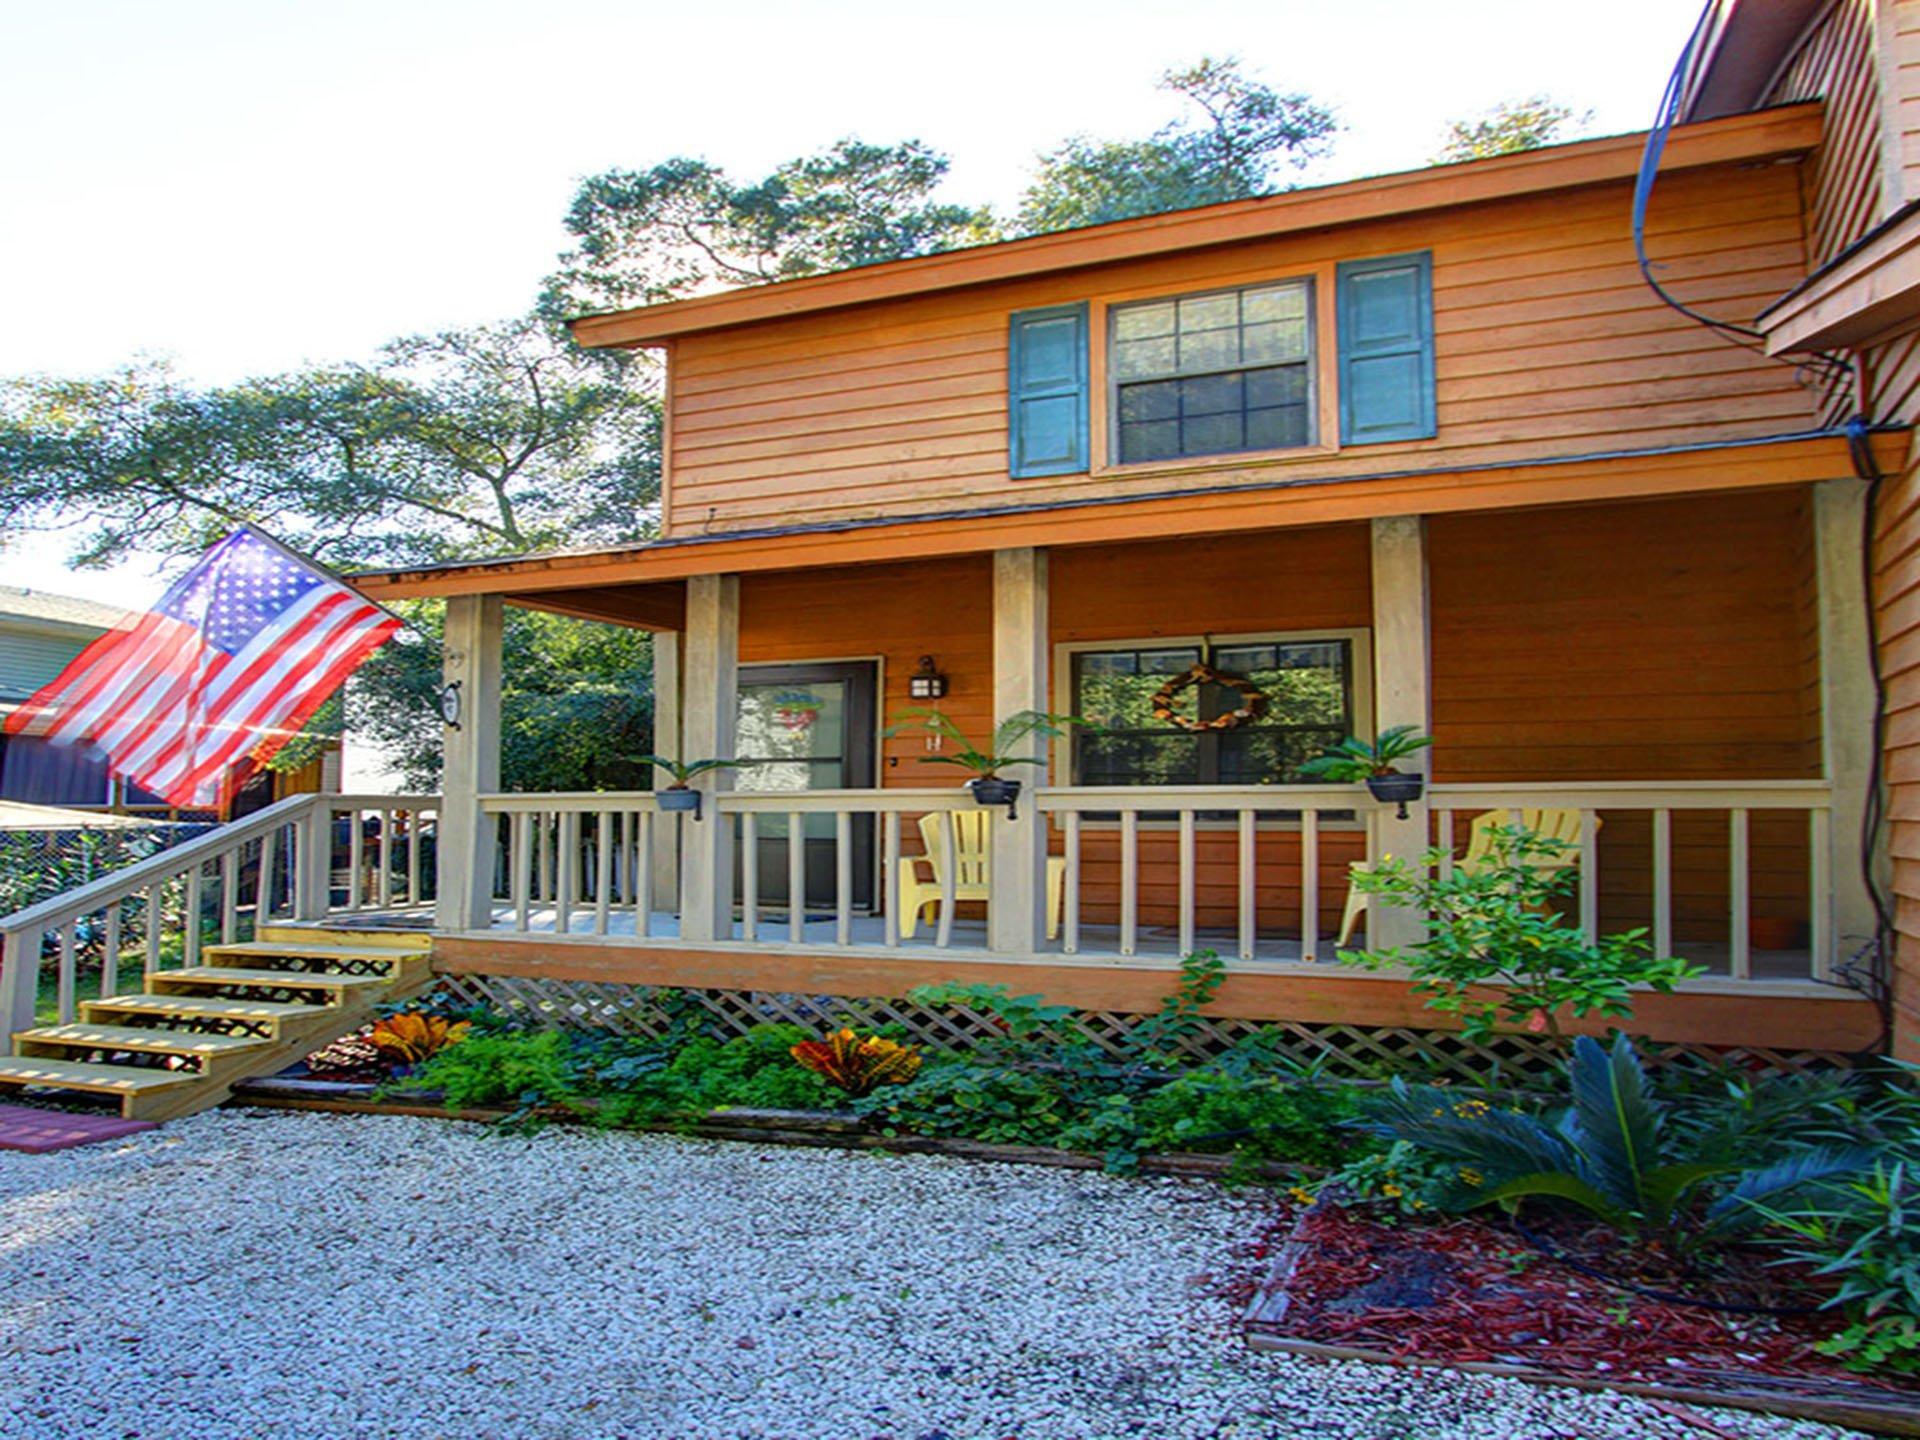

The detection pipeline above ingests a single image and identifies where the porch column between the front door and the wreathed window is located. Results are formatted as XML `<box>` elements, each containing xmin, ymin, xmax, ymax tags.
<box><xmin>987</xmin><ymin>547</ymin><xmax>1048</xmax><ymax>954</ymax></box>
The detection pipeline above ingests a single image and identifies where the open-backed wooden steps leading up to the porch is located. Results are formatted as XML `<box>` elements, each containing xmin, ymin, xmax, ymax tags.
<box><xmin>0</xmin><ymin>927</ymin><xmax>432</xmax><ymax>1119</ymax></box>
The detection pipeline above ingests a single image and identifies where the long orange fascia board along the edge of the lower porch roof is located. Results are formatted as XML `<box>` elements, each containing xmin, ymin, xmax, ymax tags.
<box><xmin>351</xmin><ymin>426</ymin><xmax>1907</xmax><ymax>610</ymax></box>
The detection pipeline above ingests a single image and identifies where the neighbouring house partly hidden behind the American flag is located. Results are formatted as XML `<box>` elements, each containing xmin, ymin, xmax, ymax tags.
<box><xmin>0</xmin><ymin>586</ymin><xmax>340</xmax><ymax>814</ymax></box>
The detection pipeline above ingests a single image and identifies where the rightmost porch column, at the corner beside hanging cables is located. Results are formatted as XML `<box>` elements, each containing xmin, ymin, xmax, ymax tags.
<box><xmin>1812</xmin><ymin>478</ymin><xmax>1876</xmax><ymax>973</ymax></box>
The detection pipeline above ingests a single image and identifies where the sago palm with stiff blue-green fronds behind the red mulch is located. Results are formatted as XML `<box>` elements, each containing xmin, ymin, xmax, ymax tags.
<box><xmin>1375</xmin><ymin>1035</ymin><xmax>1872</xmax><ymax>1250</ymax></box>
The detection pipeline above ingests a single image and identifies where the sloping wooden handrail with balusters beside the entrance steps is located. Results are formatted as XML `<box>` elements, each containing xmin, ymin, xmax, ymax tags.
<box><xmin>0</xmin><ymin>795</ymin><xmax>440</xmax><ymax>1048</ymax></box>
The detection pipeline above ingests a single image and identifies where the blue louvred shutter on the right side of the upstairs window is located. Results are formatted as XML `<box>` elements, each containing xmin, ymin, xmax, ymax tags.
<box><xmin>1334</xmin><ymin>252</ymin><xmax>1438</xmax><ymax>445</ymax></box>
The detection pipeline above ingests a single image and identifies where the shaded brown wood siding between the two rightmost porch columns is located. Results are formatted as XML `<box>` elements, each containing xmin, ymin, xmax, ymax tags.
<box><xmin>1428</xmin><ymin>490</ymin><xmax>1820</xmax><ymax>943</ymax></box>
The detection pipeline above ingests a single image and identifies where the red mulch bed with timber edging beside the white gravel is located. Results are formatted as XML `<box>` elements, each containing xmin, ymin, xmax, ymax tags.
<box><xmin>1244</xmin><ymin>1200</ymin><xmax>1920</xmax><ymax>1436</ymax></box>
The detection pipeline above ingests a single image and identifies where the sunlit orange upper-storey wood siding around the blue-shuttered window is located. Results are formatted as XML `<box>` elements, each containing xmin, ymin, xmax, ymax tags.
<box><xmin>668</xmin><ymin>163</ymin><xmax>1814</xmax><ymax>536</ymax></box>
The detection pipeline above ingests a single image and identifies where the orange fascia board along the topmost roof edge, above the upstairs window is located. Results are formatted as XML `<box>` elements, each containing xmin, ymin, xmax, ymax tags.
<box><xmin>568</xmin><ymin>102</ymin><xmax>1822</xmax><ymax>349</ymax></box>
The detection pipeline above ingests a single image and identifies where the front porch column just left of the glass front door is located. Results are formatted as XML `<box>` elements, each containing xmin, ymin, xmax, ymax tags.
<box><xmin>678</xmin><ymin>574</ymin><xmax>739</xmax><ymax>941</ymax></box>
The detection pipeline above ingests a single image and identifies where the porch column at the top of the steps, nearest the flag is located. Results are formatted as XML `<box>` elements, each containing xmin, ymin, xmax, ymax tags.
<box><xmin>434</xmin><ymin>595</ymin><xmax>503</xmax><ymax>931</ymax></box>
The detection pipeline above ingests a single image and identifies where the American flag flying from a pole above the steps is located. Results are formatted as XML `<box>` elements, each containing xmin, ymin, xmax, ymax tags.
<box><xmin>6</xmin><ymin>526</ymin><xmax>399</xmax><ymax>808</ymax></box>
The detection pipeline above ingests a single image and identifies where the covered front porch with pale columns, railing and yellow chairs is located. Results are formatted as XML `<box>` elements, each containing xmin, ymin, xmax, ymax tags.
<box><xmin>385</xmin><ymin>480</ymin><xmax>1874</xmax><ymax>1043</ymax></box>
